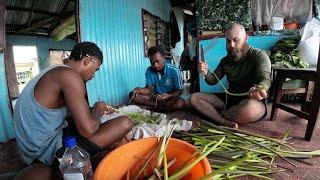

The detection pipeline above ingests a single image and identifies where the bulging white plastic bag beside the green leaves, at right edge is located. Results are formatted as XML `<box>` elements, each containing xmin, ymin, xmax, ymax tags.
<box><xmin>298</xmin><ymin>18</ymin><xmax>320</xmax><ymax>65</ymax></box>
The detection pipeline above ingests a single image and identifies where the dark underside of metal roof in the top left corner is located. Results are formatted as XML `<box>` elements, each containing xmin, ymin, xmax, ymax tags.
<box><xmin>6</xmin><ymin>0</ymin><xmax>76</xmax><ymax>36</ymax></box>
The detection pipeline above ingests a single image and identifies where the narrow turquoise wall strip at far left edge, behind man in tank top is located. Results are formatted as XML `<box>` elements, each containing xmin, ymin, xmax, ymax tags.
<box><xmin>0</xmin><ymin>54</ymin><xmax>15</xmax><ymax>142</ymax></box>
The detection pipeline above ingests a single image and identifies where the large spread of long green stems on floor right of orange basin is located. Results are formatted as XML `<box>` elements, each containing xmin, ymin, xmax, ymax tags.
<box><xmin>174</xmin><ymin>121</ymin><xmax>320</xmax><ymax>179</ymax></box>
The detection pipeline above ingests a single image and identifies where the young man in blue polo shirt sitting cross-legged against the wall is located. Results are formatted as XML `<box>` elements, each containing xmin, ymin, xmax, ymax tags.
<box><xmin>129</xmin><ymin>47</ymin><xmax>184</xmax><ymax>111</ymax></box>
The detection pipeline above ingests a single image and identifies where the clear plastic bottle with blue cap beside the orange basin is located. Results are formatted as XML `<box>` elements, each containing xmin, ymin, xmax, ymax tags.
<box><xmin>59</xmin><ymin>136</ymin><xmax>93</xmax><ymax>180</ymax></box>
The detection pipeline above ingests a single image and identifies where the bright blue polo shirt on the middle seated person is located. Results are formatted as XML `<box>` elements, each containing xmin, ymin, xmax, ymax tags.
<box><xmin>145</xmin><ymin>64</ymin><xmax>183</xmax><ymax>94</ymax></box>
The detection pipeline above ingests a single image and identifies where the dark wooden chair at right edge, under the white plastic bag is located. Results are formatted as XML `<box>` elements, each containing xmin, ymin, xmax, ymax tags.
<box><xmin>270</xmin><ymin>44</ymin><xmax>320</xmax><ymax>141</ymax></box>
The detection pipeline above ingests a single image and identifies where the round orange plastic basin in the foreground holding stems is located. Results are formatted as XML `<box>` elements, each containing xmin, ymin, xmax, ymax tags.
<box><xmin>94</xmin><ymin>138</ymin><xmax>211</xmax><ymax>180</ymax></box>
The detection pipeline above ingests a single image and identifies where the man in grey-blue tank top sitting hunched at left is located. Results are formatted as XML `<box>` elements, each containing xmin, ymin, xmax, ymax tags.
<box><xmin>14</xmin><ymin>42</ymin><xmax>132</xmax><ymax>179</ymax></box>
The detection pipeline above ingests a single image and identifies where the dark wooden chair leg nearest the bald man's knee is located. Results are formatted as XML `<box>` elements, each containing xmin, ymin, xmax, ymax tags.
<box><xmin>270</xmin><ymin>74</ymin><xmax>285</xmax><ymax>121</ymax></box>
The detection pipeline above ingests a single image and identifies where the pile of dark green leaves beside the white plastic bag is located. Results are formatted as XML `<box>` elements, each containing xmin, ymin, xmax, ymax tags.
<box><xmin>270</xmin><ymin>37</ymin><xmax>309</xmax><ymax>68</ymax></box>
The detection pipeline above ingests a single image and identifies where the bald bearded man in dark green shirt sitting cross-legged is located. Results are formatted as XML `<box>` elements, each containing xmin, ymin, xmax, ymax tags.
<box><xmin>190</xmin><ymin>24</ymin><xmax>271</xmax><ymax>128</ymax></box>
